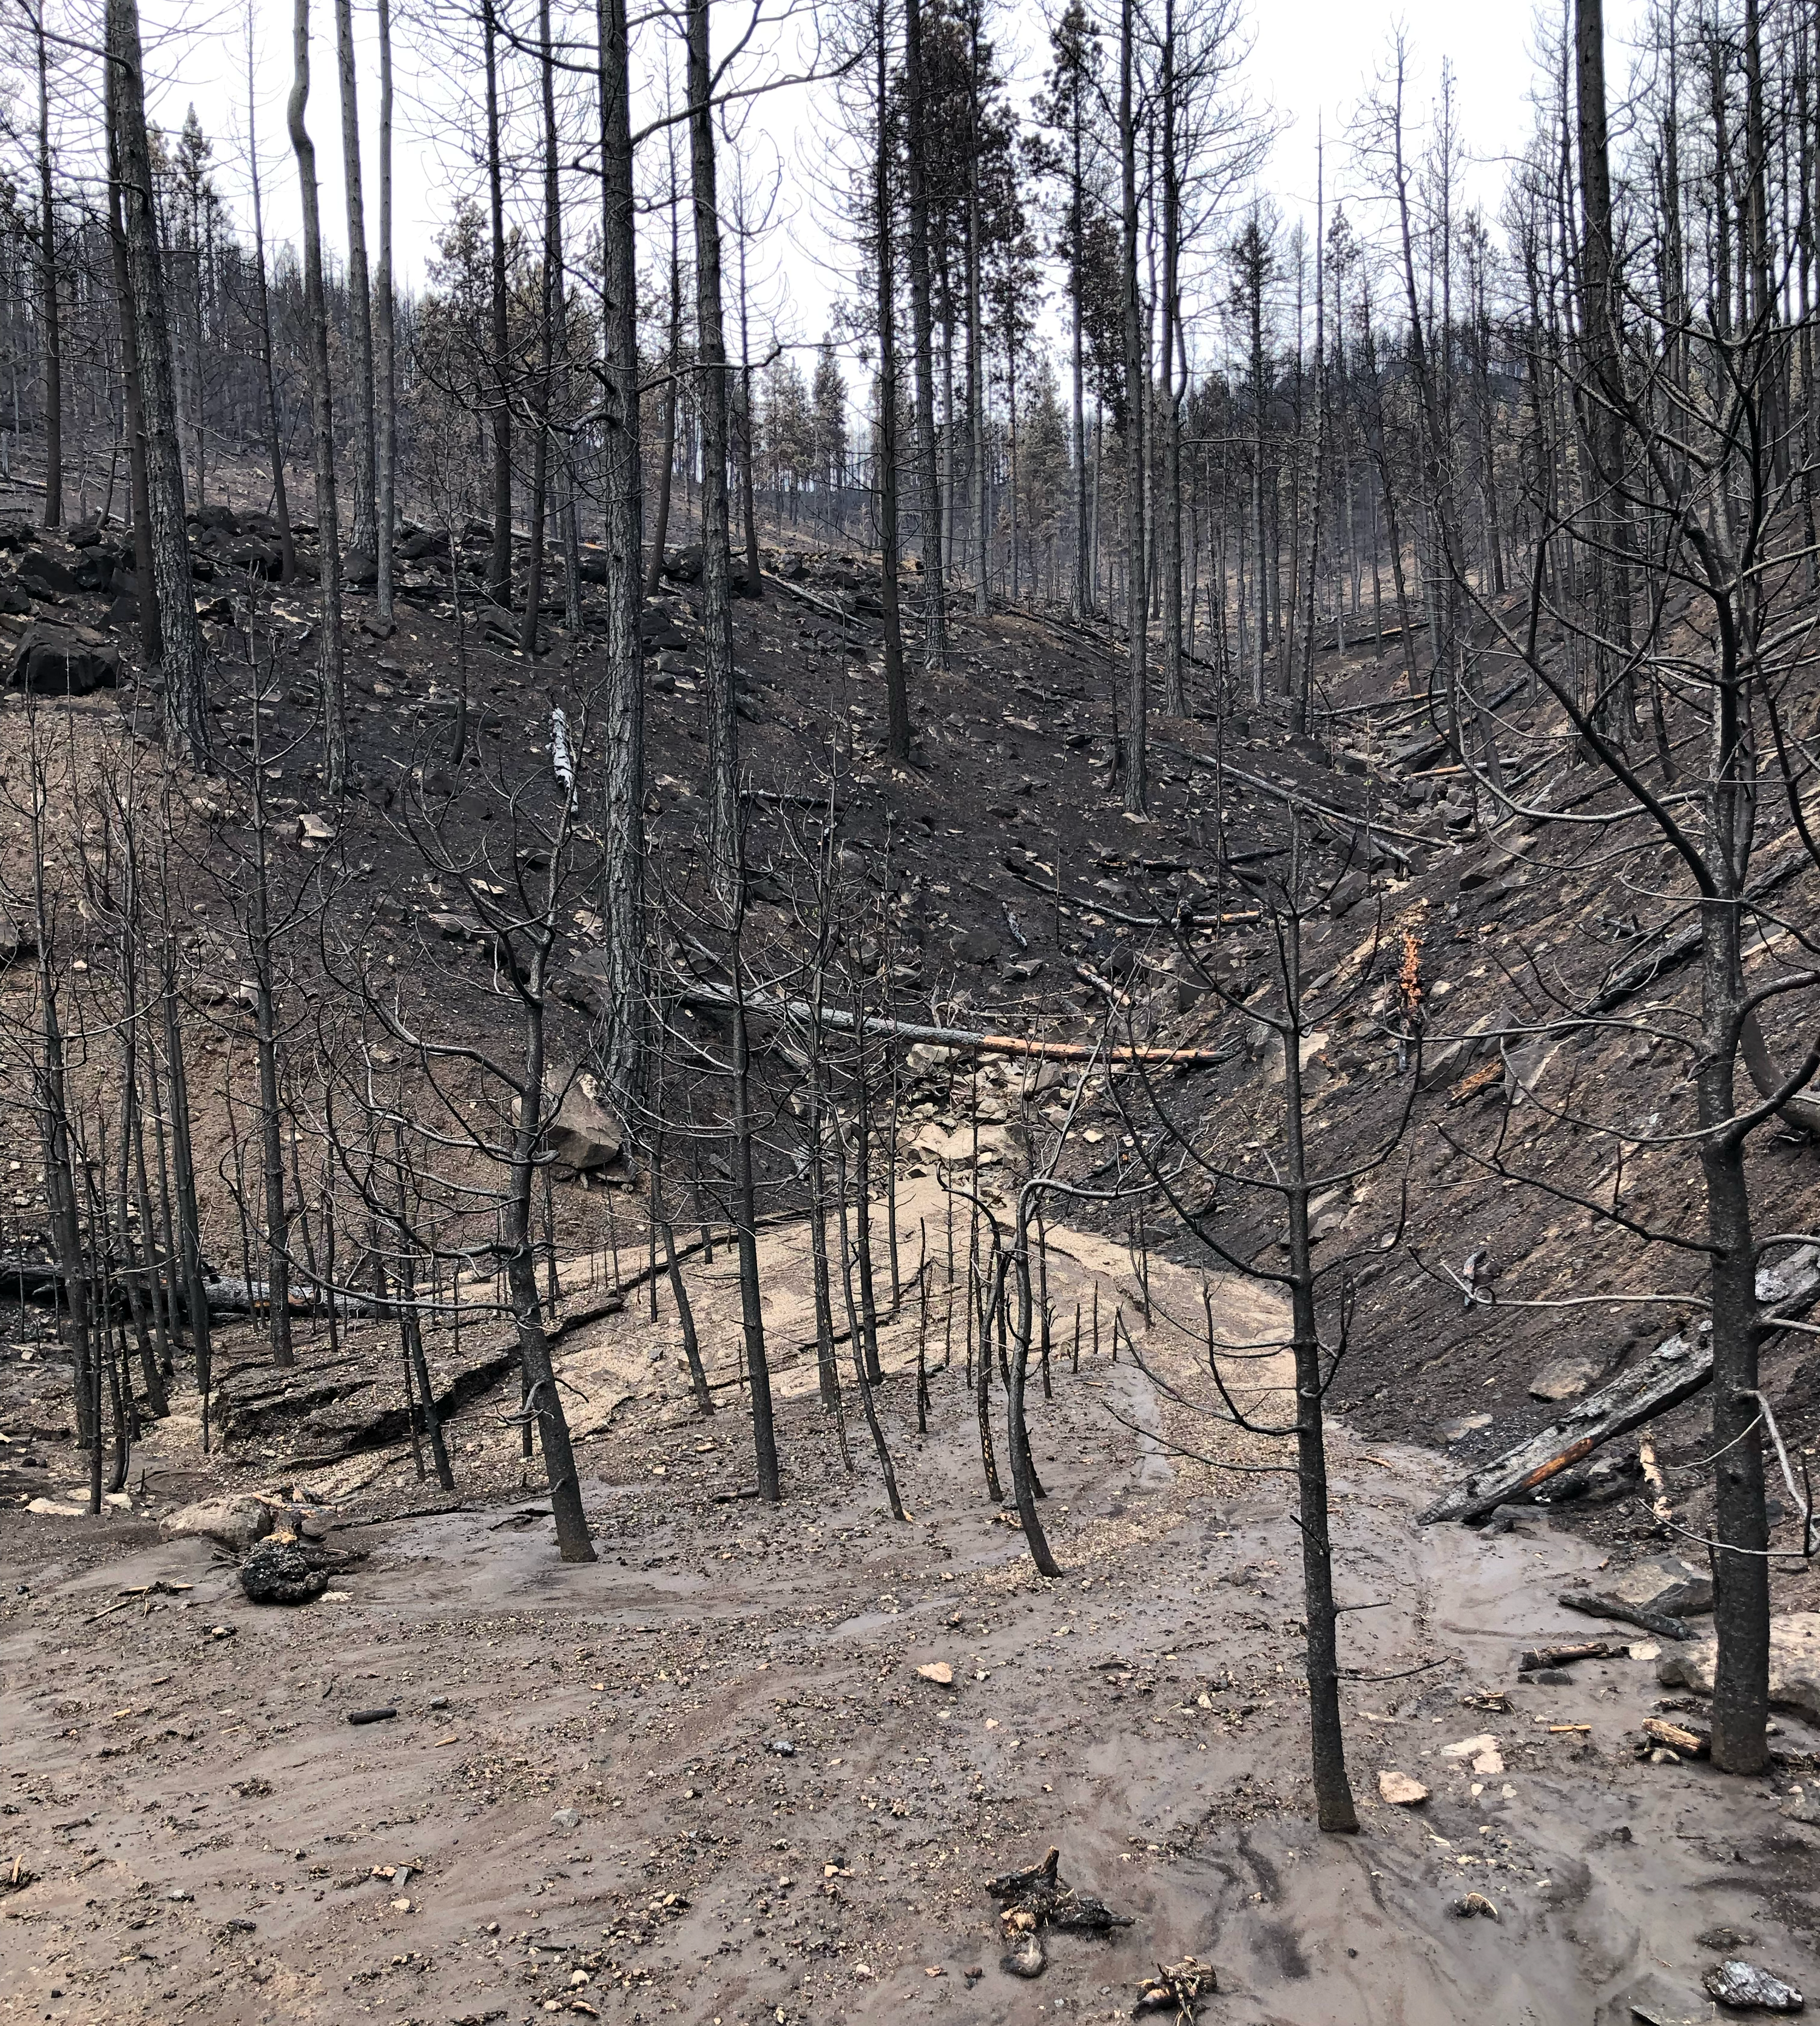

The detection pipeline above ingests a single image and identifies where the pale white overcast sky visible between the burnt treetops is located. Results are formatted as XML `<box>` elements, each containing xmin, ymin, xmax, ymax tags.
<box><xmin>78</xmin><ymin>0</ymin><xmax>1642</xmax><ymax>366</ymax></box>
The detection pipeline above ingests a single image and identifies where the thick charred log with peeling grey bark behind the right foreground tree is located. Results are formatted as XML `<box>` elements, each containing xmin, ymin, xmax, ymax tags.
<box><xmin>1423</xmin><ymin>1246</ymin><xmax>1820</xmax><ymax>1525</ymax></box>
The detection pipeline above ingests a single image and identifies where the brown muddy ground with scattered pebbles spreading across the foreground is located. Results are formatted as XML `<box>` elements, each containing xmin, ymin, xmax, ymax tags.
<box><xmin>0</xmin><ymin>1181</ymin><xmax>1820</xmax><ymax>2026</ymax></box>
